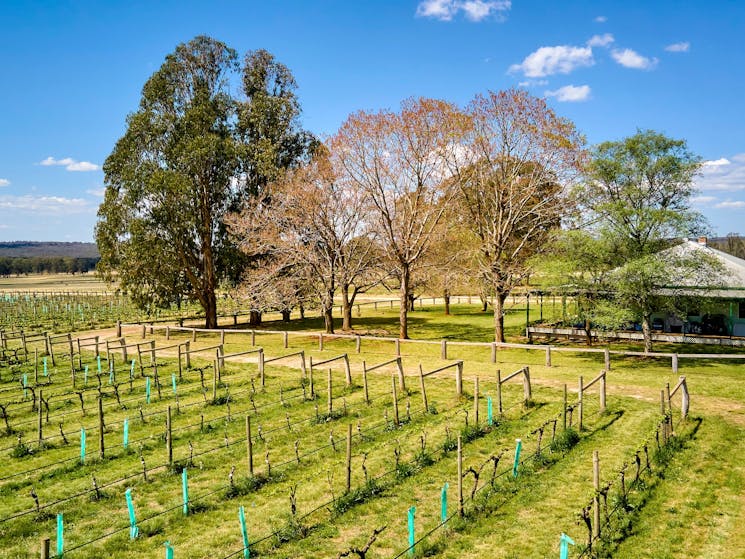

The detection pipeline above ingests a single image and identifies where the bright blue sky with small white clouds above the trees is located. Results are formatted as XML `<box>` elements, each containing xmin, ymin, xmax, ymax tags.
<box><xmin>0</xmin><ymin>0</ymin><xmax>745</xmax><ymax>241</ymax></box>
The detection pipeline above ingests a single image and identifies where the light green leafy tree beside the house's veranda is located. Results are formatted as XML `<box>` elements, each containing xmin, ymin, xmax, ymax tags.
<box><xmin>565</xmin><ymin>130</ymin><xmax>719</xmax><ymax>351</ymax></box>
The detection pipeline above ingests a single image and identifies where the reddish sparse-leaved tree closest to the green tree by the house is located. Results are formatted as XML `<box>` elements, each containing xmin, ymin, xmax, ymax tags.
<box><xmin>449</xmin><ymin>89</ymin><xmax>584</xmax><ymax>341</ymax></box>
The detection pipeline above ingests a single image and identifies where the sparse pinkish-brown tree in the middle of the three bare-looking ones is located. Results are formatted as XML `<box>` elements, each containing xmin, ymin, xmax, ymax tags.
<box><xmin>331</xmin><ymin>99</ymin><xmax>462</xmax><ymax>339</ymax></box>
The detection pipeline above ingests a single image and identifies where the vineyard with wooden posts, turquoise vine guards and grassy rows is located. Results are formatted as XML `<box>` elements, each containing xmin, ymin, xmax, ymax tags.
<box><xmin>0</xmin><ymin>301</ymin><xmax>745</xmax><ymax>558</ymax></box>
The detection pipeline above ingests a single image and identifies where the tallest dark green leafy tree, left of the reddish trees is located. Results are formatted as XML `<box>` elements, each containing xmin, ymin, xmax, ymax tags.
<box><xmin>96</xmin><ymin>36</ymin><xmax>308</xmax><ymax>328</ymax></box>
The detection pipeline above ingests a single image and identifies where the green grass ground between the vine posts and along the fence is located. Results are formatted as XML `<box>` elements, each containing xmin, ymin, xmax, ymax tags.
<box><xmin>0</xmin><ymin>305</ymin><xmax>745</xmax><ymax>558</ymax></box>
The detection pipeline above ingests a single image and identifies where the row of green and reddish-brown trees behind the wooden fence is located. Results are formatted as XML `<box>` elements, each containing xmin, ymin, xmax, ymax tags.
<box><xmin>96</xmin><ymin>36</ymin><xmax>716</xmax><ymax>350</ymax></box>
